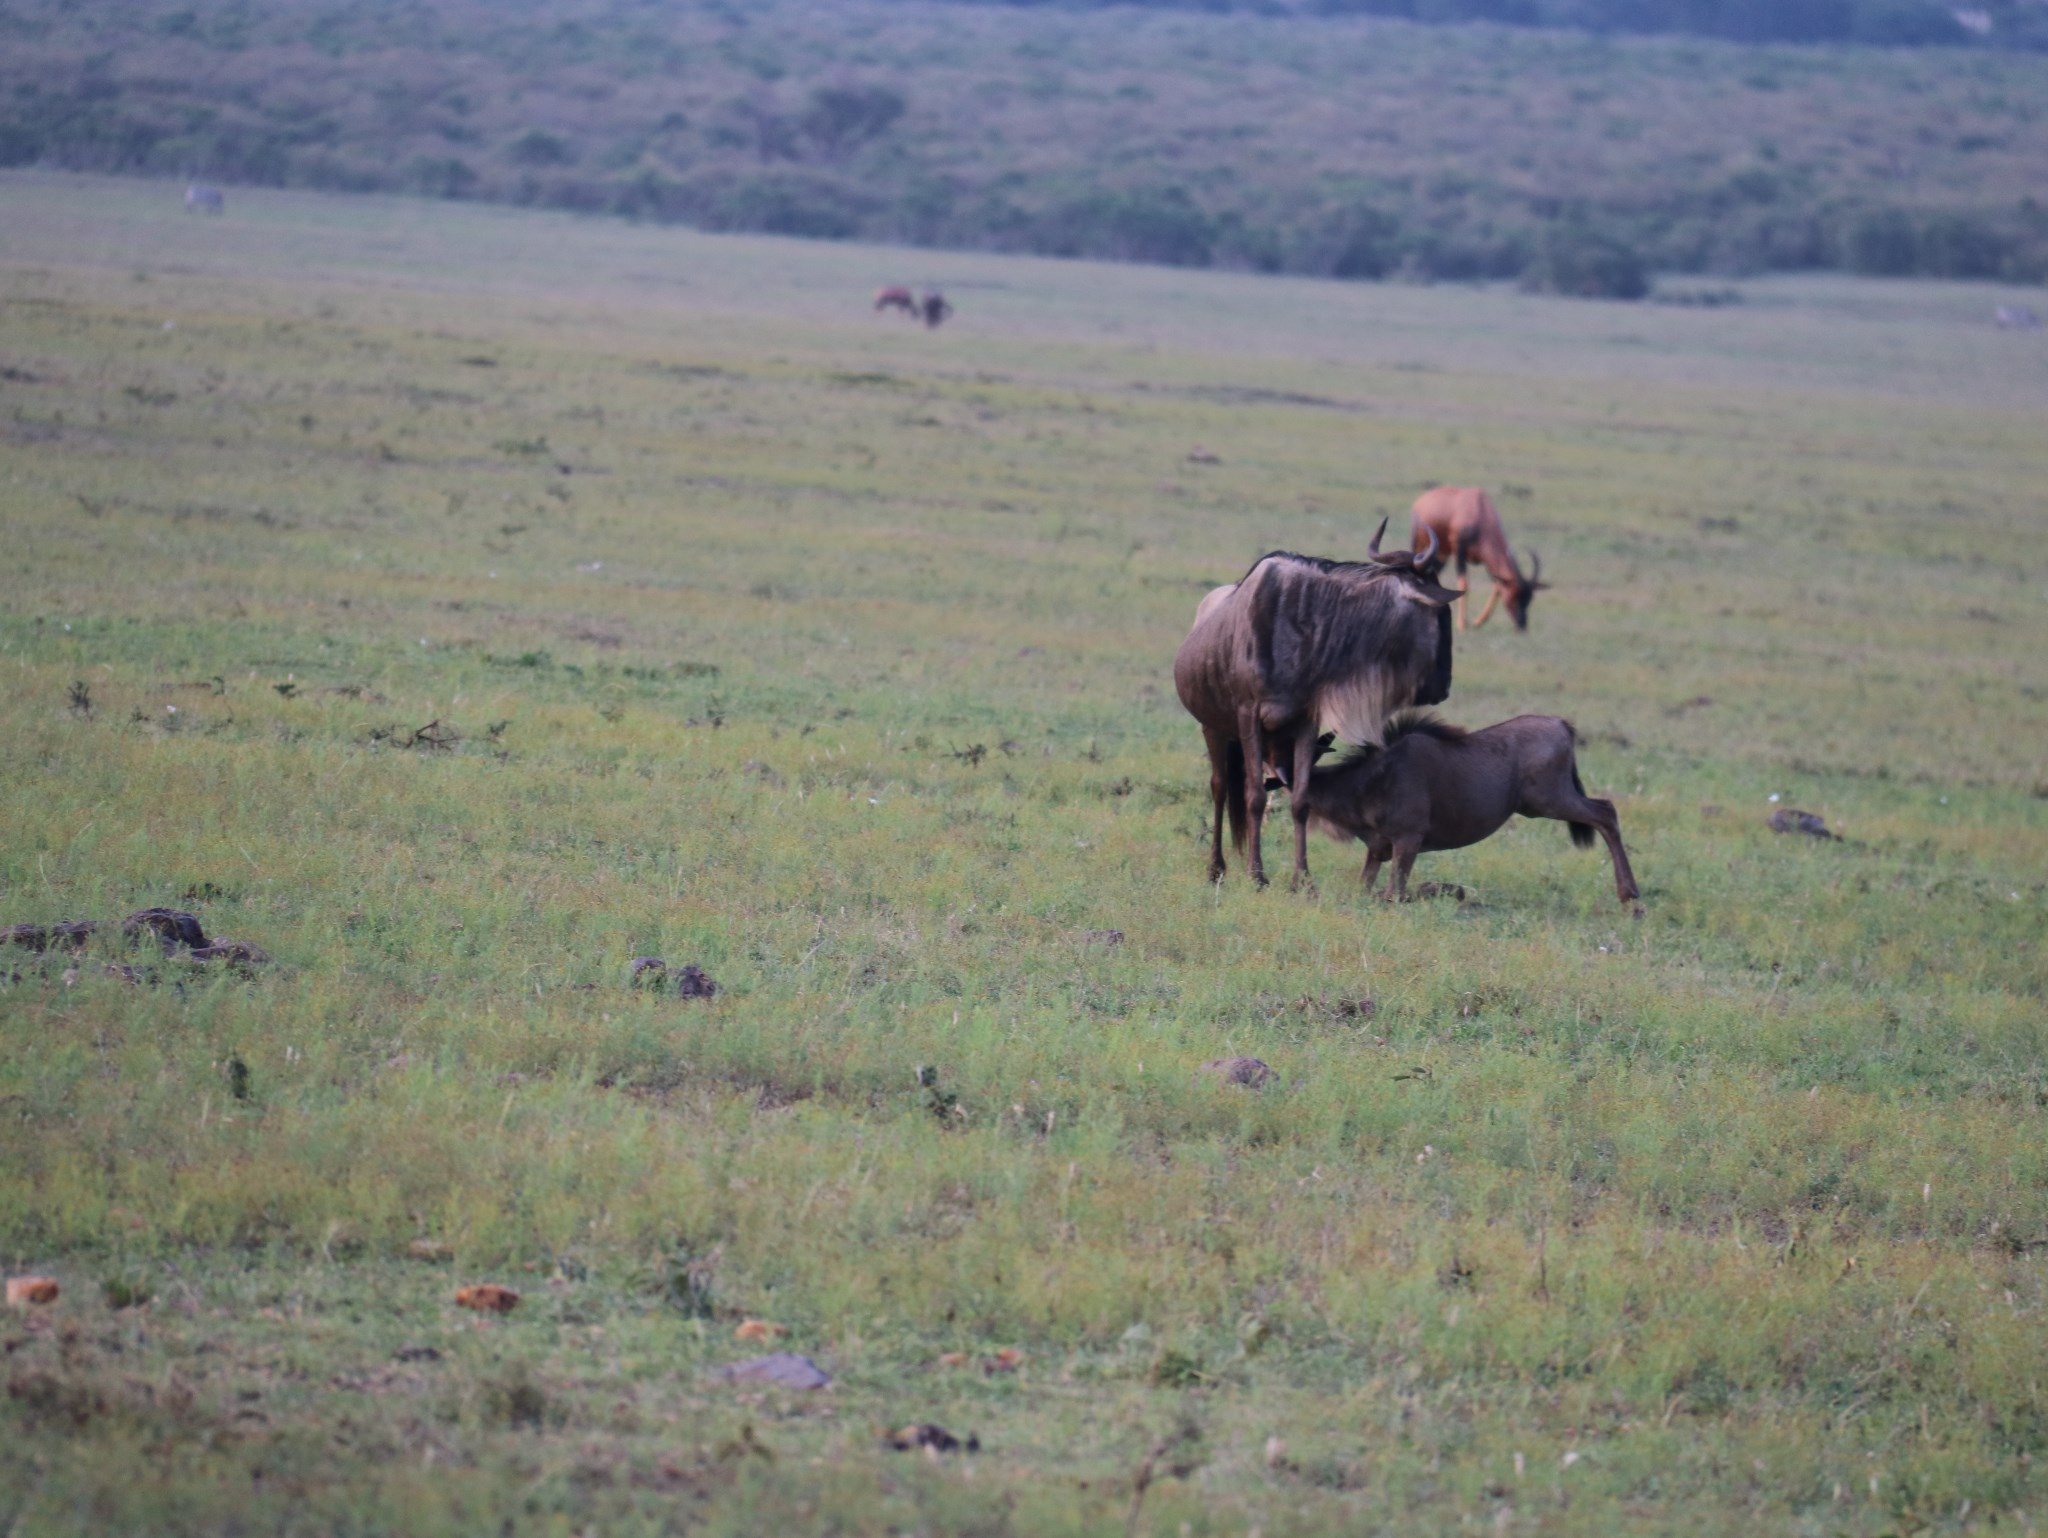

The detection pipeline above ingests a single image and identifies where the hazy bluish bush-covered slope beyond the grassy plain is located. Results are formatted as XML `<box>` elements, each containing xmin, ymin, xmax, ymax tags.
<box><xmin>0</xmin><ymin>0</ymin><xmax>2048</xmax><ymax>299</ymax></box>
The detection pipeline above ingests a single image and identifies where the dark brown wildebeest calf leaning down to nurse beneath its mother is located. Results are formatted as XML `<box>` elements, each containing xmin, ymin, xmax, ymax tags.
<box><xmin>1303</xmin><ymin>715</ymin><xmax>1640</xmax><ymax>903</ymax></box>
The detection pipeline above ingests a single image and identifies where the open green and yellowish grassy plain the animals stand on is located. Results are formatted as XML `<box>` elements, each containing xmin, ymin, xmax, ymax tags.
<box><xmin>0</xmin><ymin>176</ymin><xmax>2048</xmax><ymax>1538</ymax></box>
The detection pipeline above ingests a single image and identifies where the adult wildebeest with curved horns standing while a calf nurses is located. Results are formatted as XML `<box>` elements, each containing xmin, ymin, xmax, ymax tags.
<box><xmin>1174</xmin><ymin>522</ymin><xmax>1456</xmax><ymax>887</ymax></box>
